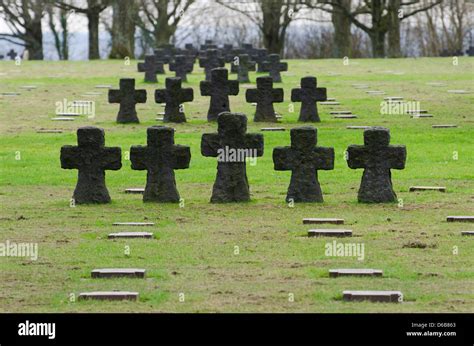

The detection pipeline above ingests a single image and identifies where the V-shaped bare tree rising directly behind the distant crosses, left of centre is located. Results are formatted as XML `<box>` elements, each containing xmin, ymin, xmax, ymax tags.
<box><xmin>137</xmin><ymin>0</ymin><xmax>195</xmax><ymax>46</ymax></box>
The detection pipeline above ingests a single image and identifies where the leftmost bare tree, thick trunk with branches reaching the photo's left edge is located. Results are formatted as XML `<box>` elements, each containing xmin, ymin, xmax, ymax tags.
<box><xmin>0</xmin><ymin>0</ymin><xmax>45</xmax><ymax>60</ymax></box>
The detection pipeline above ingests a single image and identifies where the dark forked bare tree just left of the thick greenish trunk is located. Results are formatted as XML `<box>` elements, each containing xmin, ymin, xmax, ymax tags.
<box><xmin>55</xmin><ymin>0</ymin><xmax>110</xmax><ymax>60</ymax></box>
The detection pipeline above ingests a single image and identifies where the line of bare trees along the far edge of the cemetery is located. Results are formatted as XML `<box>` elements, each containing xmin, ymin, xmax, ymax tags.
<box><xmin>0</xmin><ymin>0</ymin><xmax>473</xmax><ymax>60</ymax></box>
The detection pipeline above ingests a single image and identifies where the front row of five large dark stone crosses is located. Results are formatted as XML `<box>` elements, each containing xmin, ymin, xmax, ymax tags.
<box><xmin>61</xmin><ymin>112</ymin><xmax>406</xmax><ymax>204</ymax></box>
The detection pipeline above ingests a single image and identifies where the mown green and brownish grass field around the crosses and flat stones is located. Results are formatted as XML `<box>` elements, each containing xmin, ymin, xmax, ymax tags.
<box><xmin>0</xmin><ymin>58</ymin><xmax>474</xmax><ymax>312</ymax></box>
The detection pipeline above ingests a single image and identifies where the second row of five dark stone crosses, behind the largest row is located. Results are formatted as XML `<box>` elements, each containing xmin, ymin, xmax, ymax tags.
<box><xmin>109</xmin><ymin>72</ymin><xmax>327</xmax><ymax>123</ymax></box>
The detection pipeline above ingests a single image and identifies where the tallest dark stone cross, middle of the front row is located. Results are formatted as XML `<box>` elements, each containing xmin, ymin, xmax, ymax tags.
<box><xmin>201</xmin><ymin>112</ymin><xmax>263</xmax><ymax>203</ymax></box>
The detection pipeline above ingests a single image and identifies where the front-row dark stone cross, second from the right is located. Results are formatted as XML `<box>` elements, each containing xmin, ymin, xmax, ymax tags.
<box><xmin>273</xmin><ymin>127</ymin><xmax>334</xmax><ymax>202</ymax></box>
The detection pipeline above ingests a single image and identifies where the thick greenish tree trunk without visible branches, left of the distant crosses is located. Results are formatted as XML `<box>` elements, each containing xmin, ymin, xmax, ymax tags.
<box><xmin>109</xmin><ymin>0</ymin><xmax>138</xmax><ymax>59</ymax></box>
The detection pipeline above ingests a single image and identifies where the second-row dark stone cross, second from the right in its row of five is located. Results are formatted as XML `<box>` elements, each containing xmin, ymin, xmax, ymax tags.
<box><xmin>245</xmin><ymin>76</ymin><xmax>283</xmax><ymax>122</ymax></box>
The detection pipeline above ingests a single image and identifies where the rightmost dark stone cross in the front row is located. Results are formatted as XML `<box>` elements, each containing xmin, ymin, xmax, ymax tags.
<box><xmin>347</xmin><ymin>127</ymin><xmax>407</xmax><ymax>203</ymax></box>
